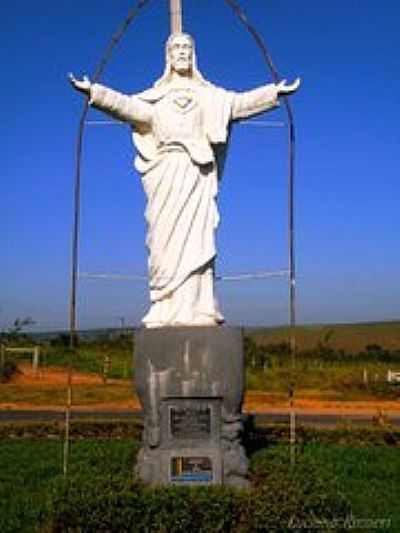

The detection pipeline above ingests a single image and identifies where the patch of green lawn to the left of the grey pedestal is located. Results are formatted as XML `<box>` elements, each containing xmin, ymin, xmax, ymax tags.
<box><xmin>0</xmin><ymin>439</ymin><xmax>138</xmax><ymax>533</ymax></box>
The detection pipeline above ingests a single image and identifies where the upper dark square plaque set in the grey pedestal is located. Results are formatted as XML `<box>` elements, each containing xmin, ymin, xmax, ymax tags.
<box><xmin>170</xmin><ymin>406</ymin><xmax>211</xmax><ymax>439</ymax></box>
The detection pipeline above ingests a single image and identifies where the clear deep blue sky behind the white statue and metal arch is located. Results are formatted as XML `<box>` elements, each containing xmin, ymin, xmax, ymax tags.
<box><xmin>0</xmin><ymin>0</ymin><xmax>400</xmax><ymax>330</ymax></box>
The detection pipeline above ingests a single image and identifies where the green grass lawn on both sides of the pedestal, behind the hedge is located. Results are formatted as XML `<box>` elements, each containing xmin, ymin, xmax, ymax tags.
<box><xmin>0</xmin><ymin>424</ymin><xmax>400</xmax><ymax>533</ymax></box>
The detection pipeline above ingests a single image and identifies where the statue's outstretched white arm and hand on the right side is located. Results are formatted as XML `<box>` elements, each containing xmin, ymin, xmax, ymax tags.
<box><xmin>232</xmin><ymin>79</ymin><xmax>300</xmax><ymax>120</ymax></box>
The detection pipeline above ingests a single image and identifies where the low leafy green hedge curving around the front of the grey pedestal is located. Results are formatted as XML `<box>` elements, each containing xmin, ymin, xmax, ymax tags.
<box><xmin>49</xmin><ymin>449</ymin><xmax>350</xmax><ymax>533</ymax></box>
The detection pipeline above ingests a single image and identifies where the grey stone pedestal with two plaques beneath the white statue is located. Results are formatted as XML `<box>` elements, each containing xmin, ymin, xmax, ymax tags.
<box><xmin>134</xmin><ymin>326</ymin><xmax>248</xmax><ymax>486</ymax></box>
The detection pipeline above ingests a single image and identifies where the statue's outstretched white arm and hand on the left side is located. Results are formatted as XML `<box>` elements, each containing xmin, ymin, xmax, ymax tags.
<box><xmin>69</xmin><ymin>74</ymin><xmax>152</xmax><ymax>124</ymax></box>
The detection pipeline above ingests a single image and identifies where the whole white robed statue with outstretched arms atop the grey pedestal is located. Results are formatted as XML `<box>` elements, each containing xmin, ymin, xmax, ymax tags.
<box><xmin>70</xmin><ymin>33</ymin><xmax>300</xmax><ymax>328</ymax></box>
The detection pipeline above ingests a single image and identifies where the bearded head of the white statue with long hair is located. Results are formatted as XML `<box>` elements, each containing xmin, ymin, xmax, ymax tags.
<box><xmin>154</xmin><ymin>33</ymin><xmax>208</xmax><ymax>87</ymax></box>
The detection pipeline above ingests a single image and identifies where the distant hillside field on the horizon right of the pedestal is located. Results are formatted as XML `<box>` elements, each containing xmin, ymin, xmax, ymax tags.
<box><xmin>245</xmin><ymin>321</ymin><xmax>400</xmax><ymax>353</ymax></box>
